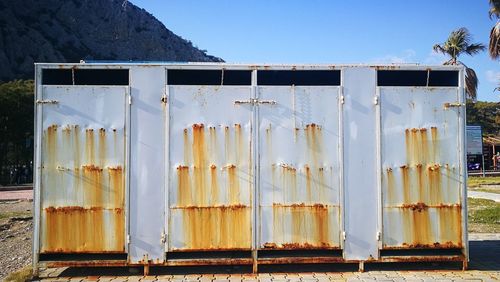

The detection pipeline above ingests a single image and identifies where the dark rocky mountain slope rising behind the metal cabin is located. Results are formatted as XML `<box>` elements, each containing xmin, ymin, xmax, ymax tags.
<box><xmin>0</xmin><ymin>0</ymin><xmax>222</xmax><ymax>81</ymax></box>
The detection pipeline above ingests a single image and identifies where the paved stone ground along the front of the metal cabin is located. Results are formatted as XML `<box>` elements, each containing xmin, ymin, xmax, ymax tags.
<box><xmin>35</xmin><ymin>233</ymin><xmax>500</xmax><ymax>282</ymax></box>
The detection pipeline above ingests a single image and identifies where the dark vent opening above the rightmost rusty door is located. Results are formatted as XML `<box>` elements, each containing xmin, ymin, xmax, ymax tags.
<box><xmin>377</xmin><ymin>70</ymin><xmax>459</xmax><ymax>87</ymax></box>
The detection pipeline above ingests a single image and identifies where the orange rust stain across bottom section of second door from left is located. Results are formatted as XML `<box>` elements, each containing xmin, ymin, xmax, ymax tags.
<box><xmin>181</xmin><ymin>205</ymin><xmax>251</xmax><ymax>250</ymax></box>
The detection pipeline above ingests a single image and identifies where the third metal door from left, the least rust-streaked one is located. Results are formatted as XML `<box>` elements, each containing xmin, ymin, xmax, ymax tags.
<box><xmin>258</xmin><ymin>86</ymin><xmax>341</xmax><ymax>249</ymax></box>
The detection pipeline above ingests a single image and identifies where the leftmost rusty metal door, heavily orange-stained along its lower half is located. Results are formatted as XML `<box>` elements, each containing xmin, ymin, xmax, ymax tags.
<box><xmin>40</xmin><ymin>86</ymin><xmax>127</xmax><ymax>253</ymax></box>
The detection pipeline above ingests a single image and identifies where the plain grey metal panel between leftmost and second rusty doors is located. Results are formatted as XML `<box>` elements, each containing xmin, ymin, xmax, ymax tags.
<box><xmin>128</xmin><ymin>65</ymin><xmax>168</xmax><ymax>263</ymax></box>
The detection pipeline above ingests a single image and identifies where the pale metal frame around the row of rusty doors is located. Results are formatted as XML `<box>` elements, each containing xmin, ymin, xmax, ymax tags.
<box><xmin>33</xmin><ymin>62</ymin><xmax>469</xmax><ymax>272</ymax></box>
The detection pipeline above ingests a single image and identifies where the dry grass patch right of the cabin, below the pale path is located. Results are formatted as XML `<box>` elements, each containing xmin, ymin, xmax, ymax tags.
<box><xmin>468</xmin><ymin>198</ymin><xmax>500</xmax><ymax>233</ymax></box>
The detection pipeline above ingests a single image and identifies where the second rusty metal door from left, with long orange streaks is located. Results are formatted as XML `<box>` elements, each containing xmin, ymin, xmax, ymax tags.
<box><xmin>168</xmin><ymin>86</ymin><xmax>254</xmax><ymax>251</ymax></box>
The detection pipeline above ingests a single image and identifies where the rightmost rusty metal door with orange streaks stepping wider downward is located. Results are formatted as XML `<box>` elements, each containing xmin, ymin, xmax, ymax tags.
<box><xmin>380</xmin><ymin>87</ymin><xmax>463</xmax><ymax>248</ymax></box>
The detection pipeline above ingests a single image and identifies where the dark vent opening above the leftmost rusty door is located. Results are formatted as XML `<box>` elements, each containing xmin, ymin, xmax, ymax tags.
<box><xmin>42</xmin><ymin>69</ymin><xmax>129</xmax><ymax>85</ymax></box>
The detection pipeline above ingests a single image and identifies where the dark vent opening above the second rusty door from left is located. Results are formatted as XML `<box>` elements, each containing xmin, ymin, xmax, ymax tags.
<box><xmin>168</xmin><ymin>70</ymin><xmax>252</xmax><ymax>85</ymax></box>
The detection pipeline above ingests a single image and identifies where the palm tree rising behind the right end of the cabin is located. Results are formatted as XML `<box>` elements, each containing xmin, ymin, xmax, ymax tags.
<box><xmin>432</xmin><ymin>27</ymin><xmax>484</xmax><ymax>101</ymax></box>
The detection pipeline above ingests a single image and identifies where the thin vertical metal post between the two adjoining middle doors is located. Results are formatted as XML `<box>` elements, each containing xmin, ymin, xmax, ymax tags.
<box><xmin>250</xmin><ymin>70</ymin><xmax>260</xmax><ymax>273</ymax></box>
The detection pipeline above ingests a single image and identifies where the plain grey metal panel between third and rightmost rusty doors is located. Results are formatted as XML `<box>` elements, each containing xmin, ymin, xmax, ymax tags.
<box><xmin>343</xmin><ymin>67</ymin><xmax>379</xmax><ymax>260</ymax></box>
